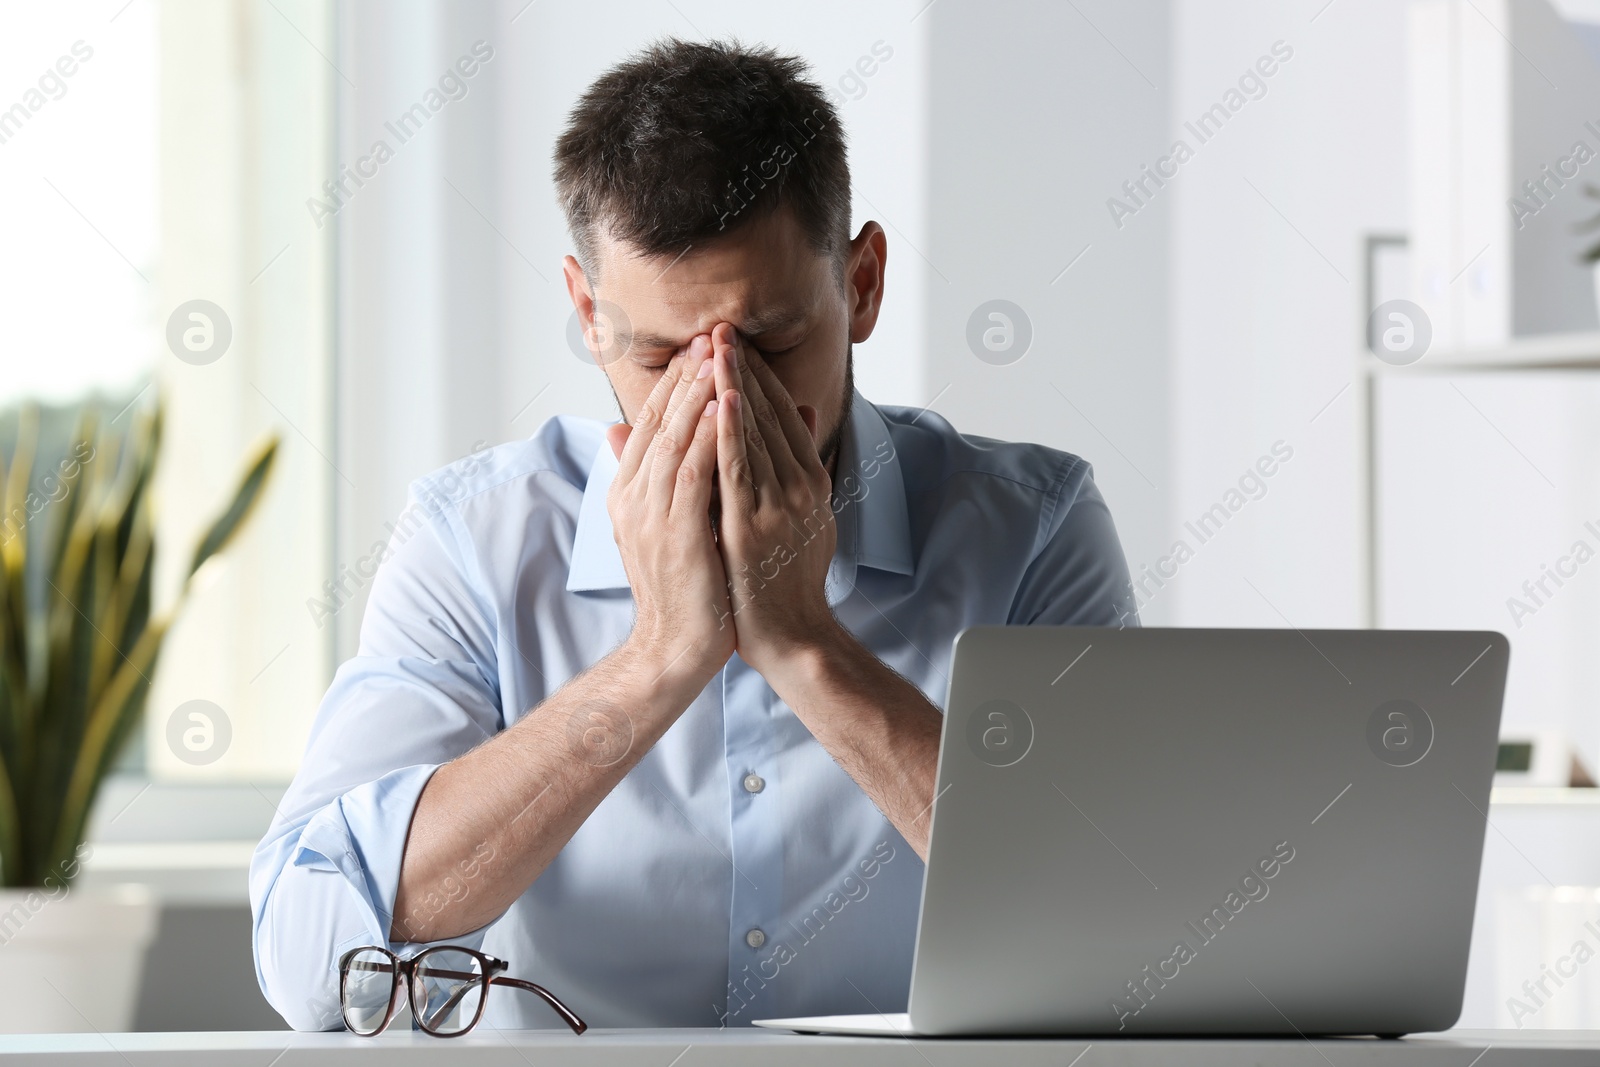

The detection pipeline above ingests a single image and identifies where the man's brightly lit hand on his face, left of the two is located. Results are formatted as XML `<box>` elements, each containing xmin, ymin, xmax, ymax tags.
<box><xmin>606</xmin><ymin>334</ymin><xmax>734</xmax><ymax>685</ymax></box>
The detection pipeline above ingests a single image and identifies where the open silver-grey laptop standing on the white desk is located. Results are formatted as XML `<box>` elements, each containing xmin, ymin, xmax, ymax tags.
<box><xmin>757</xmin><ymin>627</ymin><xmax>1510</xmax><ymax>1037</ymax></box>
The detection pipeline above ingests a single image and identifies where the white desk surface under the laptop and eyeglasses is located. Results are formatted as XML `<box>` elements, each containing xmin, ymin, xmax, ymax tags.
<box><xmin>0</xmin><ymin>1027</ymin><xmax>1600</xmax><ymax>1067</ymax></box>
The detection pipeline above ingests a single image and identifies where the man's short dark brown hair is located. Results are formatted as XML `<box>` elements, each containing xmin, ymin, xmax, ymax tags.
<box><xmin>555</xmin><ymin>38</ymin><xmax>850</xmax><ymax>278</ymax></box>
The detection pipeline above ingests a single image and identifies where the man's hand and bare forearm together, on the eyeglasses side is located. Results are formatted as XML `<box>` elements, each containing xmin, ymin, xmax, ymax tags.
<box><xmin>390</xmin><ymin>334</ymin><xmax>736</xmax><ymax>942</ymax></box>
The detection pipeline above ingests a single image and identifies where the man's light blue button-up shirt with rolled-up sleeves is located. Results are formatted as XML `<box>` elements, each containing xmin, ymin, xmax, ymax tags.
<box><xmin>250</xmin><ymin>394</ymin><xmax>1138</xmax><ymax>1030</ymax></box>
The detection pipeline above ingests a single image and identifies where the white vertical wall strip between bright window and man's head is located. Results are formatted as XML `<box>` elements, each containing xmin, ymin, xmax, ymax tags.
<box><xmin>326</xmin><ymin>0</ymin><xmax>496</xmax><ymax>661</ymax></box>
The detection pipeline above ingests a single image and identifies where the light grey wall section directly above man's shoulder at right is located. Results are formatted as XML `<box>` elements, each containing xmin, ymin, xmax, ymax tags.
<box><xmin>922</xmin><ymin>0</ymin><xmax>1176</xmax><ymax>624</ymax></box>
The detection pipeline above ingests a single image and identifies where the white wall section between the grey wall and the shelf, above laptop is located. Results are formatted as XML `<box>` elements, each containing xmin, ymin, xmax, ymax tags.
<box><xmin>1158</xmin><ymin>0</ymin><xmax>1406</xmax><ymax>627</ymax></box>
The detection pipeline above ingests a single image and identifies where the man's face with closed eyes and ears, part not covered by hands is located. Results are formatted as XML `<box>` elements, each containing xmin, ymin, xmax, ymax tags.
<box><xmin>566</xmin><ymin>208</ymin><xmax>883</xmax><ymax>466</ymax></box>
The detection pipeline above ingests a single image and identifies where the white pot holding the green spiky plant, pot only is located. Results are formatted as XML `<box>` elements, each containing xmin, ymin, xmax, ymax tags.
<box><xmin>0</xmin><ymin>885</ymin><xmax>157</xmax><ymax>1033</ymax></box>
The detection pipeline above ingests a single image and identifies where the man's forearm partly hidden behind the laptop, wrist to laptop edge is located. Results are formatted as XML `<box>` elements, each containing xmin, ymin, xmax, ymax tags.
<box><xmin>763</xmin><ymin>627</ymin><xmax>944</xmax><ymax>859</ymax></box>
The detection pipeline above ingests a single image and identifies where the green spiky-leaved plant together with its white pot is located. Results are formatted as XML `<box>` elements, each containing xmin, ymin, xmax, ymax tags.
<box><xmin>0</xmin><ymin>395</ymin><xmax>278</xmax><ymax>1032</ymax></box>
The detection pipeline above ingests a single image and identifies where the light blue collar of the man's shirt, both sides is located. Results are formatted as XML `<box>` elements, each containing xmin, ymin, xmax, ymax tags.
<box><xmin>566</xmin><ymin>390</ymin><xmax>914</xmax><ymax>605</ymax></box>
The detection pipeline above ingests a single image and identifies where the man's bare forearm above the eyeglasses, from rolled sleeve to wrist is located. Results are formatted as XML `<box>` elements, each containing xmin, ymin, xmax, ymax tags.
<box><xmin>390</xmin><ymin>645</ymin><xmax>706</xmax><ymax>942</ymax></box>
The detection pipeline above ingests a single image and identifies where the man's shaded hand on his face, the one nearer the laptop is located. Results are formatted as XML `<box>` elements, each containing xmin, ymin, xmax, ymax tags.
<box><xmin>710</xmin><ymin>323</ymin><xmax>840</xmax><ymax>678</ymax></box>
